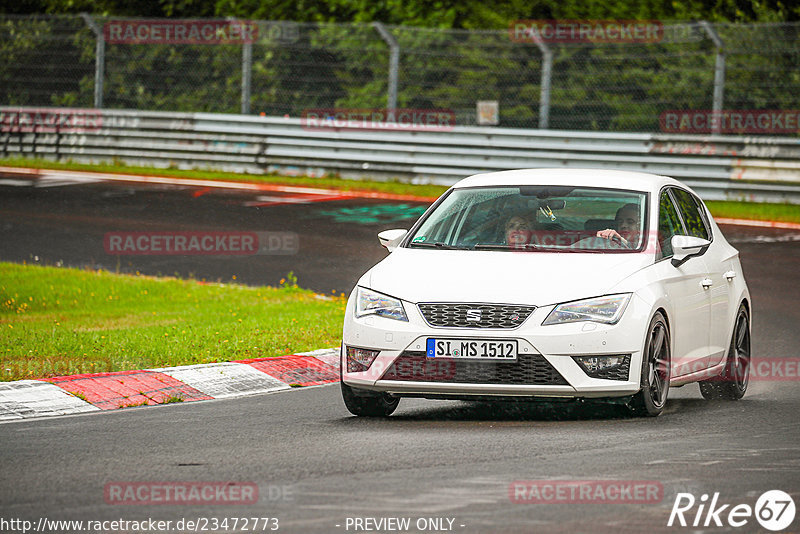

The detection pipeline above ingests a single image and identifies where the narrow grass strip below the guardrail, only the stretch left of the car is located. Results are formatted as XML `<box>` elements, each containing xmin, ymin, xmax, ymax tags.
<box><xmin>0</xmin><ymin>158</ymin><xmax>447</xmax><ymax>202</ymax></box>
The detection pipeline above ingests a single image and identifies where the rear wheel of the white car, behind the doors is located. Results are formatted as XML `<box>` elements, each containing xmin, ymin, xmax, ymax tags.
<box><xmin>699</xmin><ymin>304</ymin><xmax>750</xmax><ymax>400</ymax></box>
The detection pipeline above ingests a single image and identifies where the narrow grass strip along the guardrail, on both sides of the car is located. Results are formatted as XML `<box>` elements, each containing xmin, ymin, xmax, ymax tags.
<box><xmin>0</xmin><ymin>158</ymin><xmax>800</xmax><ymax>223</ymax></box>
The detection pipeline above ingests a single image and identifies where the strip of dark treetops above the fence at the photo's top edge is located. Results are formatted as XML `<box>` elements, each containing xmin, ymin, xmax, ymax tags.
<box><xmin>0</xmin><ymin>0</ymin><xmax>800</xmax><ymax>24</ymax></box>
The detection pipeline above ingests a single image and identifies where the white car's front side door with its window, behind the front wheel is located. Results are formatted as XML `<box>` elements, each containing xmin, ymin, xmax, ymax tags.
<box><xmin>656</xmin><ymin>188</ymin><xmax>711</xmax><ymax>376</ymax></box>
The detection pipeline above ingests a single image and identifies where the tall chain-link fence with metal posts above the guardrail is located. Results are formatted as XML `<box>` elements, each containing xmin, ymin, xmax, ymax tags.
<box><xmin>0</xmin><ymin>16</ymin><xmax>800</xmax><ymax>132</ymax></box>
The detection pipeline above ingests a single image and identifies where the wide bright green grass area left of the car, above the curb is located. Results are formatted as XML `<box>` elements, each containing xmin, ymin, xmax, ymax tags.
<box><xmin>0</xmin><ymin>262</ymin><xmax>345</xmax><ymax>382</ymax></box>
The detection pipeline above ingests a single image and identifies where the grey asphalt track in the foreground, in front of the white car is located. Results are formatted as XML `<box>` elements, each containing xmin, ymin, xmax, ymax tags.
<box><xmin>0</xmin><ymin>378</ymin><xmax>800</xmax><ymax>533</ymax></box>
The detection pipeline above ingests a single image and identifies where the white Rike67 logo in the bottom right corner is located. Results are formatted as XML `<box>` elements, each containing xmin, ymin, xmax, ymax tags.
<box><xmin>667</xmin><ymin>490</ymin><xmax>795</xmax><ymax>532</ymax></box>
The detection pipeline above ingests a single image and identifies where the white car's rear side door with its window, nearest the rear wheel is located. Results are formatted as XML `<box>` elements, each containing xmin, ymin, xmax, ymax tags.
<box><xmin>673</xmin><ymin>188</ymin><xmax>730</xmax><ymax>367</ymax></box>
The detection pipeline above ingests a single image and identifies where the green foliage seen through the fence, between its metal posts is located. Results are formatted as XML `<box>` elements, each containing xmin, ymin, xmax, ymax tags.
<box><xmin>0</xmin><ymin>4</ymin><xmax>800</xmax><ymax>132</ymax></box>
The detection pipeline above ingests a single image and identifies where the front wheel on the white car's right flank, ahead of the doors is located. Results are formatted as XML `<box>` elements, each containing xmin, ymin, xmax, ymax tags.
<box><xmin>629</xmin><ymin>312</ymin><xmax>672</xmax><ymax>417</ymax></box>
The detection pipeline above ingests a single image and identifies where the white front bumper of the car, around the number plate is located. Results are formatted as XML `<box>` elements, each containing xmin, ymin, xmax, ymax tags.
<box><xmin>341</xmin><ymin>295</ymin><xmax>649</xmax><ymax>398</ymax></box>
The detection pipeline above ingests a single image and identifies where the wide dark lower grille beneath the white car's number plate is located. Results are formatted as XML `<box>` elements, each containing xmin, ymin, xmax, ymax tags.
<box><xmin>381</xmin><ymin>351</ymin><xmax>569</xmax><ymax>386</ymax></box>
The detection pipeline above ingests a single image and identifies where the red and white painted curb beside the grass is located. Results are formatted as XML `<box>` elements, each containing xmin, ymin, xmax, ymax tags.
<box><xmin>0</xmin><ymin>348</ymin><xmax>339</xmax><ymax>422</ymax></box>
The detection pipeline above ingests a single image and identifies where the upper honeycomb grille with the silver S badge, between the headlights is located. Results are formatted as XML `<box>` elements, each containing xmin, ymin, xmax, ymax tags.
<box><xmin>417</xmin><ymin>302</ymin><xmax>536</xmax><ymax>328</ymax></box>
